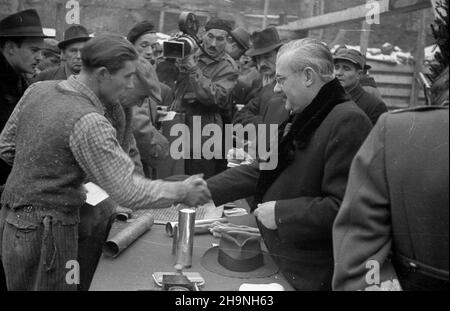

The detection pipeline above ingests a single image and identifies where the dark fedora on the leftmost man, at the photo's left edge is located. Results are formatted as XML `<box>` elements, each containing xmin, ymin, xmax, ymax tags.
<box><xmin>0</xmin><ymin>9</ymin><xmax>52</xmax><ymax>38</ymax></box>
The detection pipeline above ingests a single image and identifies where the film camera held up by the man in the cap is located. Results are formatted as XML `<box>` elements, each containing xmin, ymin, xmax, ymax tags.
<box><xmin>163</xmin><ymin>12</ymin><xmax>201</xmax><ymax>58</ymax></box>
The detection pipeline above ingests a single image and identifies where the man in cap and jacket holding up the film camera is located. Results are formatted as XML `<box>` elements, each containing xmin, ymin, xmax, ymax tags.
<box><xmin>173</xmin><ymin>18</ymin><xmax>238</xmax><ymax>178</ymax></box>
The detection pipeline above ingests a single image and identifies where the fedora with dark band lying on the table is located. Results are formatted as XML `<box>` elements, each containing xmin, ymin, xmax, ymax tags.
<box><xmin>202</xmin><ymin>231</ymin><xmax>278</xmax><ymax>278</ymax></box>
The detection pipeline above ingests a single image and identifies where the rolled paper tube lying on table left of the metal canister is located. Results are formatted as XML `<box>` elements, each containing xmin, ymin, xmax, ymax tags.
<box><xmin>103</xmin><ymin>214</ymin><xmax>154</xmax><ymax>257</ymax></box>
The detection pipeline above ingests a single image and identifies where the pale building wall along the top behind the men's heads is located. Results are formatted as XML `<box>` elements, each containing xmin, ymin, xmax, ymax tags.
<box><xmin>0</xmin><ymin>0</ymin><xmax>440</xmax><ymax>52</ymax></box>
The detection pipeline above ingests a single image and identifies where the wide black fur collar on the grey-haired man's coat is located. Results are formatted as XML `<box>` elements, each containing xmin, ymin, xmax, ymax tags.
<box><xmin>255</xmin><ymin>79</ymin><xmax>350</xmax><ymax>203</ymax></box>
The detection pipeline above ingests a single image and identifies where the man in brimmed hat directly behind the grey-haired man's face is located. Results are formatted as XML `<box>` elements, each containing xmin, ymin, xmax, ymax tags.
<box><xmin>233</xmin><ymin>27</ymin><xmax>289</xmax><ymax>146</ymax></box>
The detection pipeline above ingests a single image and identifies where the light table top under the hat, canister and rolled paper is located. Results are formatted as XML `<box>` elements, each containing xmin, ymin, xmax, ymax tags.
<box><xmin>90</xmin><ymin>201</ymin><xmax>292</xmax><ymax>291</ymax></box>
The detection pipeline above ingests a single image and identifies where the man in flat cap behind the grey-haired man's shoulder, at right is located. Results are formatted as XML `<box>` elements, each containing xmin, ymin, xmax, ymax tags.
<box><xmin>334</xmin><ymin>48</ymin><xmax>387</xmax><ymax>124</ymax></box>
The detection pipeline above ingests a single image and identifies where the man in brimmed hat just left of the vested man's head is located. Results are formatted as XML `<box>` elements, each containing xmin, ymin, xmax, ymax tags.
<box><xmin>36</xmin><ymin>25</ymin><xmax>91</xmax><ymax>81</ymax></box>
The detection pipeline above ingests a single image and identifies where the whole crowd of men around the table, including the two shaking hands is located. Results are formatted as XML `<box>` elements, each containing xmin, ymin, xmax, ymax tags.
<box><xmin>0</xmin><ymin>9</ymin><xmax>449</xmax><ymax>290</ymax></box>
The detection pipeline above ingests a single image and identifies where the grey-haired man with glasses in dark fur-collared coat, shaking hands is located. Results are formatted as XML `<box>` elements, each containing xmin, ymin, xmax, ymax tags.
<box><xmin>207</xmin><ymin>38</ymin><xmax>371</xmax><ymax>290</ymax></box>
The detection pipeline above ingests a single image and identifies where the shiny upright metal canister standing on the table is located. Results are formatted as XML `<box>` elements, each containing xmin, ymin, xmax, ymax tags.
<box><xmin>176</xmin><ymin>208</ymin><xmax>195</xmax><ymax>268</ymax></box>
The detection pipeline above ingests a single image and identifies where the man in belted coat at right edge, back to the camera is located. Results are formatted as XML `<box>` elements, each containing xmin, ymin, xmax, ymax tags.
<box><xmin>333</xmin><ymin>71</ymin><xmax>449</xmax><ymax>291</ymax></box>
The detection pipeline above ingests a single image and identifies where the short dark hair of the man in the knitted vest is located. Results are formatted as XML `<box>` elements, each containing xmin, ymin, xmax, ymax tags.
<box><xmin>81</xmin><ymin>34</ymin><xmax>138</xmax><ymax>74</ymax></box>
